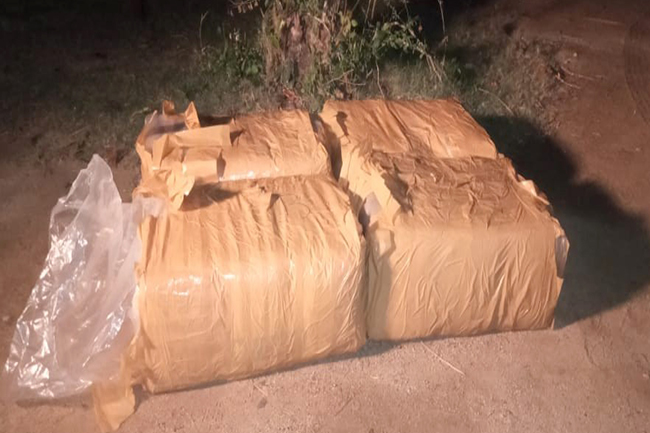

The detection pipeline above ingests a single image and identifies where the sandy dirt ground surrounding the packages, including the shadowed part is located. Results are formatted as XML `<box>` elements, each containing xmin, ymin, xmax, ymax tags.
<box><xmin>0</xmin><ymin>0</ymin><xmax>650</xmax><ymax>433</ymax></box>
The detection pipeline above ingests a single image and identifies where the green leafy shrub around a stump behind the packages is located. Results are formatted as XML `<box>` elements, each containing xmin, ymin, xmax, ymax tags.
<box><xmin>205</xmin><ymin>0</ymin><xmax>443</xmax><ymax>109</ymax></box>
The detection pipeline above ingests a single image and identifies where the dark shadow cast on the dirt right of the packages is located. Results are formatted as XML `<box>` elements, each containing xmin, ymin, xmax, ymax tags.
<box><xmin>478</xmin><ymin>117</ymin><xmax>650</xmax><ymax>327</ymax></box>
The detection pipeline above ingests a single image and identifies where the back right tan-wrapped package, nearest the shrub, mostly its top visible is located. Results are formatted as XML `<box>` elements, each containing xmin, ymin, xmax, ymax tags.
<box><xmin>320</xmin><ymin>99</ymin><xmax>497</xmax><ymax>212</ymax></box>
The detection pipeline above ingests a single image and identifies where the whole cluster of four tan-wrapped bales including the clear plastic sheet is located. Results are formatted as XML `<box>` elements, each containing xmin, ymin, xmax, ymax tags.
<box><xmin>5</xmin><ymin>100</ymin><xmax>568</xmax><ymax>430</ymax></box>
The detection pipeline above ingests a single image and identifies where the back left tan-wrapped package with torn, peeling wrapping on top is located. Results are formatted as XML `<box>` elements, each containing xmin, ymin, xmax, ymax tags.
<box><xmin>136</xmin><ymin>105</ymin><xmax>331</xmax><ymax>208</ymax></box>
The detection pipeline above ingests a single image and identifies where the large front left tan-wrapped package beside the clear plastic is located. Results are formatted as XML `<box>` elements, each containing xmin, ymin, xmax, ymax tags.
<box><xmin>95</xmin><ymin>176</ymin><xmax>366</xmax><ymax>428</ymax></box>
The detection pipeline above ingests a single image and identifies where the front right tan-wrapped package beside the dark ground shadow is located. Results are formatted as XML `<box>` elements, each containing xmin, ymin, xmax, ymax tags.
<box><xmin>366</xmin><ymin>154</ymin><xmax>568</xmax><ymax>340</ymax></box>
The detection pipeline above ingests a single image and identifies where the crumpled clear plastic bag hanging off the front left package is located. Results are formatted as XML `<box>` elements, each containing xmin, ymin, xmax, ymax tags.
<box><xmin>2</xmin><ymin>155</ymin><xmax>163</xmax><ymax>400</ymax></box>
